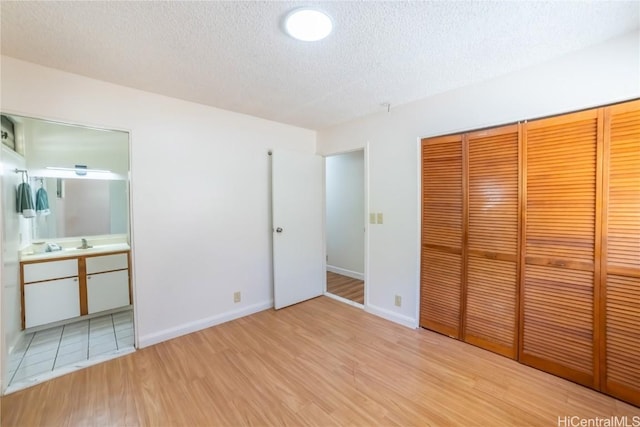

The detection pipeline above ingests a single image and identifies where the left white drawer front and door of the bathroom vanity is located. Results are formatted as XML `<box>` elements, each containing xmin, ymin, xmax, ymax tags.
<box><xmin>22</xmin><ymin>258</ymin><xmax>80</xmax><ymax>328</ymax></box>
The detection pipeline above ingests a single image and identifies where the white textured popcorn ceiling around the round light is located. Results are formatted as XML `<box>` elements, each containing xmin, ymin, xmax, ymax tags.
<box><xmin>0</xmin><ymin>0</ymin><xmax>640</xmax><ymax>129</ymax></box>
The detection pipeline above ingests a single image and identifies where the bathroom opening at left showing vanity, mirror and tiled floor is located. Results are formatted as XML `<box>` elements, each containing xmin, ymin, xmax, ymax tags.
<box><xmin>0</xmin><ymin>112</ymin><xmax>135</xmax><ymax>394</ymax></box>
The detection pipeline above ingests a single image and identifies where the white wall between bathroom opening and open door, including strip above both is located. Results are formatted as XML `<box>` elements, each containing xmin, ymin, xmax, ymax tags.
<box><xmin>0</xmin><ymin>57</ymin><xmax>316</xmax><ymax>354</ymax></box>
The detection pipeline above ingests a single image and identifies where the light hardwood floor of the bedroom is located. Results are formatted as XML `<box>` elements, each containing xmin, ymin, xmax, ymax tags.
<box><xmin>1</xmin><ymin>297</ymin><xmax>640</xmax><ymax>427</ymax></box>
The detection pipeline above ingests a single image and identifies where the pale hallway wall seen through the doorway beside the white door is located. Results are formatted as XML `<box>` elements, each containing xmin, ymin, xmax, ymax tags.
<box><xmin>325</xmin><ymin>150</ymin><xmax>365</xmax><ymax>279</ymax></box>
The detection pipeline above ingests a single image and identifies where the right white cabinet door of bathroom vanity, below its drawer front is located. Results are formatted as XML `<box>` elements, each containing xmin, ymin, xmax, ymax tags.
<box><xmin>87</xmin><ymin>270</ymin><xmax>130</xmax><ymax>314</ymax></box>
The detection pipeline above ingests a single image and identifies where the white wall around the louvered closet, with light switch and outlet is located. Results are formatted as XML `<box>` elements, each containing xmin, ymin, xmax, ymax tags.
<box><xmin>318</xmin><ymin>32</ymin><xmax>640</xmax><ymax>326</ymax></box>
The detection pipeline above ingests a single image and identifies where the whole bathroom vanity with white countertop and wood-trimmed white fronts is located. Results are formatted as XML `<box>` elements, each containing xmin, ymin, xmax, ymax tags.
<box><xmin>20</xmin><ymin>243</ymin><xmax>132</xmax><ymax>329</ymax></box>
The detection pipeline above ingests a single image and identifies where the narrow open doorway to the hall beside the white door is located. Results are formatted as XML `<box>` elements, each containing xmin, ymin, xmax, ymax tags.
<box><xmin>325</xmin><ymin>149</ymin><xmax>366</xmax><ymax>307</ymax></box>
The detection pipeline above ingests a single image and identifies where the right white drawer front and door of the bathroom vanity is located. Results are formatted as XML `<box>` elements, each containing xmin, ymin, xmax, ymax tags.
<box><xmin>85</xmin><ymin>253</ymin><xmax>131</xmax><ymax>314</ymax></box>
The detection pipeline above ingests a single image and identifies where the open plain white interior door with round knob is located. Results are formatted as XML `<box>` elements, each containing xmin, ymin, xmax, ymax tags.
<box><xmin>272</xmin><ymin>150</ymin><xmax>326</xmax><ymax>309</ymax></box>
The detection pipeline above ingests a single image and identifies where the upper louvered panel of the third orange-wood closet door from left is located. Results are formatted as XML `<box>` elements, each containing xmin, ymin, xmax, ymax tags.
<box><xmin>526</xmin><ymin>113</ymin><xmax>597</xmax><ymax>263</ymax></box>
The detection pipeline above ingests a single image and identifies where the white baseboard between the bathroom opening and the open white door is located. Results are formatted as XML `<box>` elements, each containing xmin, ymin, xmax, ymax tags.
<box><xmin>138</xmin><ymin>300</ymin><xmax>273</xmax><ymax>348</ymax></box>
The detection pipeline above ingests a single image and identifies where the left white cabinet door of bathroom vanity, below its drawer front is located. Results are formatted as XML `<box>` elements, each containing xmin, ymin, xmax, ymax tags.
<box><xmin>24</xmin><ymin>277</ymin><xmax>80</xmax><ymax>328</ymax></box>
